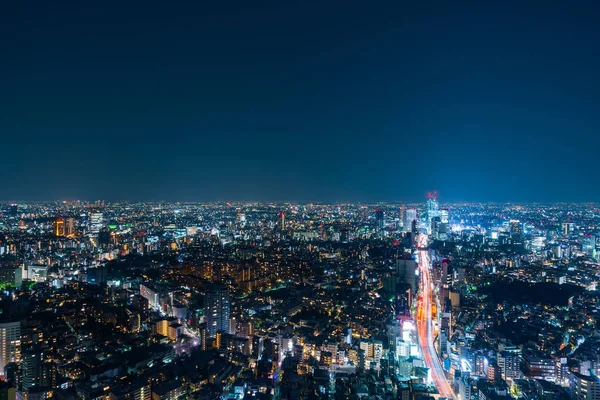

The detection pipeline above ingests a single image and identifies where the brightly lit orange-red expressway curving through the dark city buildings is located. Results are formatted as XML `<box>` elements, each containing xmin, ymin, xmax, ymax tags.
<box><xmin>417</xmin><ymin>250</ymin><xmax>455</xmax><ymax>399</ymax></box>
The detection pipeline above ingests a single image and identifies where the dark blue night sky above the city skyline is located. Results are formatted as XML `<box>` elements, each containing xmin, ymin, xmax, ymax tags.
<box><xmin>0</xmin><ymin>0</ymin><xmax>600</xmax><ymax>201</ymax></box>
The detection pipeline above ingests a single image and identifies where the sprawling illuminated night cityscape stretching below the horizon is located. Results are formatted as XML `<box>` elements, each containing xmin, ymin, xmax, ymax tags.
<box><xmin>0</xmin><ymin>198</ymin><xmax>600</xmax><ymax>400</ymax></box>
